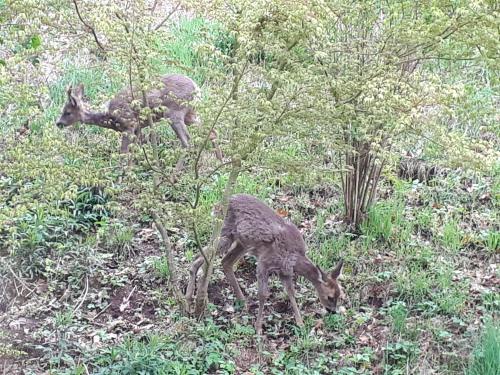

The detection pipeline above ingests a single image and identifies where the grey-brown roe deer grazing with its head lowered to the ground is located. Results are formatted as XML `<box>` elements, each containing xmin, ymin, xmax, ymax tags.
<box><xmin>186</xmin><ymin>194</ymin><xmax>343</xmax><ymax>335</ymax></box>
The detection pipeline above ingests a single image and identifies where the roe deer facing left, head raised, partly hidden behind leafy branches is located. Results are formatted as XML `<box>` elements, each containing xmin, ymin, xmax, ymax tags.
<box><xmin>56</xmin><ymin>74</ymin><xmax>221</xmax><ymax>158</ymax></box>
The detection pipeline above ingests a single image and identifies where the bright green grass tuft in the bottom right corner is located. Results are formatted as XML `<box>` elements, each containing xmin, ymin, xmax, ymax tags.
<box><xmin>466</xmin><ymin>321</ymin><xmax>500</xmax><ymax>375</ymax></box>
